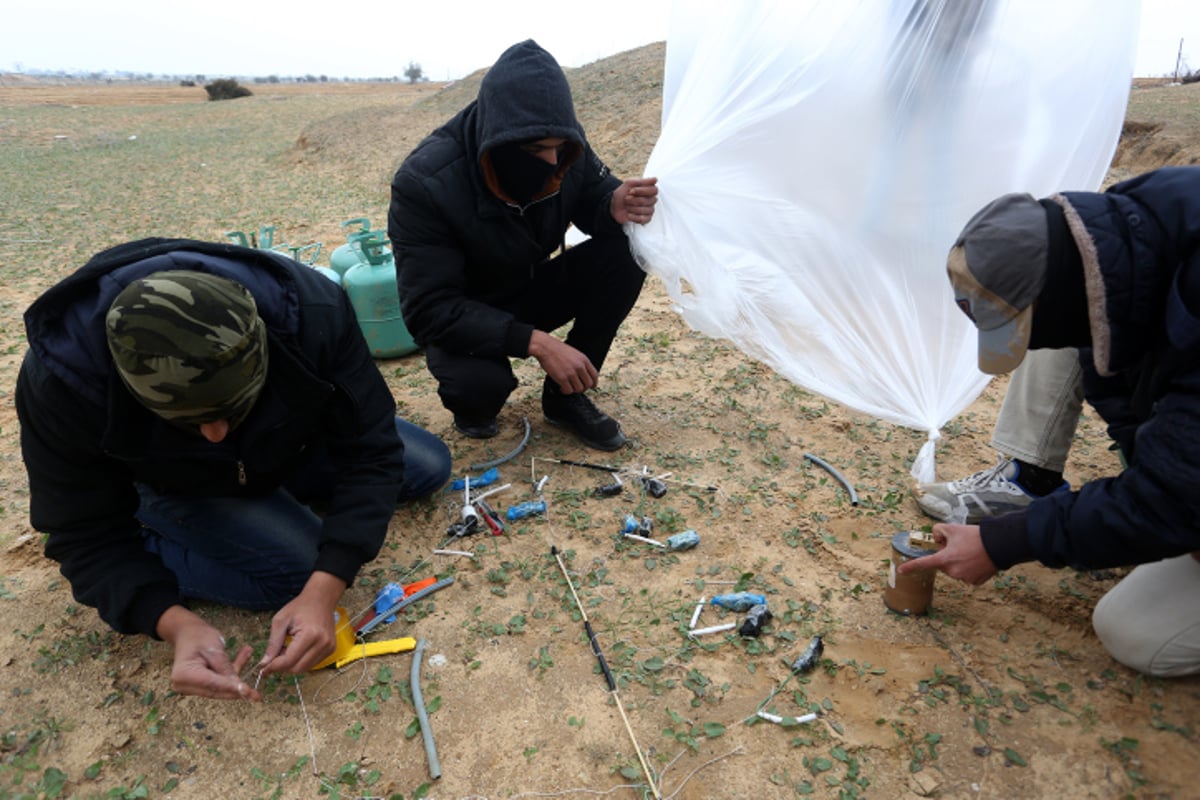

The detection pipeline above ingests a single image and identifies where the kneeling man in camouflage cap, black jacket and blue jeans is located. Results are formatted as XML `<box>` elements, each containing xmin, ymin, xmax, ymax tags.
<box><xmin>16</xmin><ymin>240</ymin><xmax>450</xmax><ymax>699</ymax></box>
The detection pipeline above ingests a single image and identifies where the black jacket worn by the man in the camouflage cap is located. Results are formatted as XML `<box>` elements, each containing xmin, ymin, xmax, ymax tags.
<box><xmin>16</xmin><ymin>239</ymin><xmax>403</xmax><ymax>636</ymax></box>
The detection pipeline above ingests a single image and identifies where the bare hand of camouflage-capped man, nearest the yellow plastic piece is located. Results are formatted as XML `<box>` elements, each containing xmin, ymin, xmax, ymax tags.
<box><xmin>258</xmin><ymin>572</ymin><xmax>349</xmax><ymax>675</ymax></box>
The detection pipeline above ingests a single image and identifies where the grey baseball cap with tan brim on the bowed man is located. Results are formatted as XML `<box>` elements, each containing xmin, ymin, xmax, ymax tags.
<box><xmin>946</xmin><ymin>194</ymin><xmax>1050</xmax><ymax>375</ymax></box>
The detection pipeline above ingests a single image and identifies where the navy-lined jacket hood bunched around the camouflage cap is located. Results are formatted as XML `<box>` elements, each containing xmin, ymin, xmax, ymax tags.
<box><xmin>25</xmin><ymin>239</ymin><xmax>300</xmax><ymax>404</ymax></box>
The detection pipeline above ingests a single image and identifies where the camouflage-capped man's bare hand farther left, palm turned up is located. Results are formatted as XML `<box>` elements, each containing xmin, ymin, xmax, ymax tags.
<box><xmin>158</xmin><ymin>606</ymin><xmax>262</xmax><ymax>700</ymax></box>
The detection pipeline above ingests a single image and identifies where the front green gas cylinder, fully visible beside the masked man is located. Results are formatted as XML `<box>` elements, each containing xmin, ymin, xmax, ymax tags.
<box><xmin>342</xmin><ymin>230</ymin><xmax>416</xmax><ymax>359</ymax></box>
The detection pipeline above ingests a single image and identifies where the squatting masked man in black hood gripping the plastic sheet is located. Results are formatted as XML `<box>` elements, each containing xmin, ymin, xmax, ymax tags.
<box><xmin>388</xmin><ymin>40</ymin><xmax>658</xmax><ymax>450</ymax></box>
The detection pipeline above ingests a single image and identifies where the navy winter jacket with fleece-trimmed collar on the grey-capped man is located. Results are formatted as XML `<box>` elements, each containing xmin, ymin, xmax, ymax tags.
<box><xmin>982</xmin><ymin>167</ymin><xmax>1200</xmax><ymax>569</ymax></box>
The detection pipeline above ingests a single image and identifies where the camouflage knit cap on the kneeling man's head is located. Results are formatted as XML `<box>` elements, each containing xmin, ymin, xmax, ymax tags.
<box><xmin>104</xmin><ymin>270</ymin><xmax>266</xmax><ymax>426</ymax></box>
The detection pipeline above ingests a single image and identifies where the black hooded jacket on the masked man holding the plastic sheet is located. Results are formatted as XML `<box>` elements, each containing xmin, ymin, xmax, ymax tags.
<box><xmin>388</xmin><ymin>40</ymin><xmax>620</xmax><ymax>357</ymax></box>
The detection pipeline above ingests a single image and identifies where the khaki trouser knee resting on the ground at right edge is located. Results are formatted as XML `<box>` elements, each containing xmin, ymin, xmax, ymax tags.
<box><xmin>1092</xmin><ymin>555</ymin><xmax>1200</xmax><ymax>678</ymax></box>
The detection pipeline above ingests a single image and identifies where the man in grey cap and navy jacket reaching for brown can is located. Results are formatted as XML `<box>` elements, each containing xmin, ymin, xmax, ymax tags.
<box><xmin>899</xmin><ymin>167</ymin><xmax>1200</xmax><ymax>676</ymax></box>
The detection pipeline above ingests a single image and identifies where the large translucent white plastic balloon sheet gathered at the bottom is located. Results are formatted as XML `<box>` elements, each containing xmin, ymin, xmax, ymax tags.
<box><xmin>629</xmin><ymin>0</ymin><xmax>1139</xmax><ymax>481</ymax></box>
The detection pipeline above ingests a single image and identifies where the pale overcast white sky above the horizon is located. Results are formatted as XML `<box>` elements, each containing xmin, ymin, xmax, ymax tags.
<box><xmin>0</xmin><ymin>0</ymin><xmax>1200</xmax><ymax>80</ymax></box>
